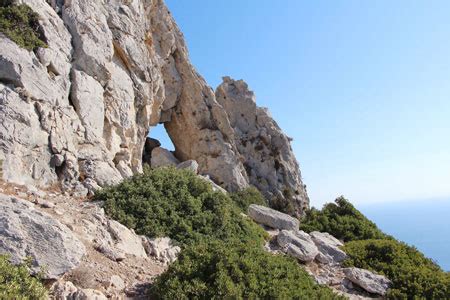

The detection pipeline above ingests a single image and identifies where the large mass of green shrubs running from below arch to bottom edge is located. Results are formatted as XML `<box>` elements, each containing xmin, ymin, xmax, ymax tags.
<box><xmin>95</xmin><ymin>168</ymin><xmax>338</xmax><ymax>299</ymax></box>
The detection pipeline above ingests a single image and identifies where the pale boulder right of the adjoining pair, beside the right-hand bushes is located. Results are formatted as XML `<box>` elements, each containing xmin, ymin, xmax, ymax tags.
<box><xmin>310</xmin><ymin>231</ymin><xmax>347</xmax><ymax>264</ymax></box>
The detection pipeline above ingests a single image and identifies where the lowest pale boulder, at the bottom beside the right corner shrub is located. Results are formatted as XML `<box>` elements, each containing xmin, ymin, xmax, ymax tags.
<box><xmin>343</xmin><ymin>268</ymin><xmax>391</xmax><ymax>296</ymax></box>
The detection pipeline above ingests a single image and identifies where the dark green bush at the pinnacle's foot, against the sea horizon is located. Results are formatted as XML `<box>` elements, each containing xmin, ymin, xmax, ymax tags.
<box><xmin>300</xmin><ymin>197</ymin><xmax>387</xmax><ymax>242</ymax></box>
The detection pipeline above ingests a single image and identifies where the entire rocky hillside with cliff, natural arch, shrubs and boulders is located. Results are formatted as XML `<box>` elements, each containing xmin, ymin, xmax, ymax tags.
<box><xmin>0</xmin><ymin>0</ymin><xmax>450</xmax><ymax>300</ymax></box>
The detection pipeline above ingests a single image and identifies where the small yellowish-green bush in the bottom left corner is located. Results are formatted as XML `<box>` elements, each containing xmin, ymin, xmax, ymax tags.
<box><xmin>0</xmin><ymin>255</ymin><xmax>47</xmax><ymax>299</ymax></box>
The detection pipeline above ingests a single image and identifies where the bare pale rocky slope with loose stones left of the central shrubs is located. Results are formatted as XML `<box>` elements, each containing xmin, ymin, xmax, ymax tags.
<box><xmin>0</xmin><ymin>180</ymin><xmax>169</xmax><ymax>299</ymax></box>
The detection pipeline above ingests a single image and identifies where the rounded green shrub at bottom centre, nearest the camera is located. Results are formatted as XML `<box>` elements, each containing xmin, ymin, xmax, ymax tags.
<box><xmin>152</xmin><ymin>241</ymin><xmax>345</xmax><ymax>299</ymax></box>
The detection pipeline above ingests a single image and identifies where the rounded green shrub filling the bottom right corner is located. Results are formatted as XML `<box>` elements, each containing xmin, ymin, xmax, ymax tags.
<box><xmin>344</xmin><ymin>239</ymin><xmax>450</xmax><ymax>299</ymax></box>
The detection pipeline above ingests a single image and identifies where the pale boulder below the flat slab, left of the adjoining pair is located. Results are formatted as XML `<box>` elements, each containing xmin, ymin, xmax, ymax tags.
<box><xmin>277</xmin><ymin>230</ymin><xmax>319</xmax><ymax>262</ymax></box>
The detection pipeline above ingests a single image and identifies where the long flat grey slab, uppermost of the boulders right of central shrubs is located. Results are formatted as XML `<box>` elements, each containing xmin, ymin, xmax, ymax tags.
<box><xmin>248</xmin><ymin>204</ymin><xmax>300</xmax><ymax>230</ymax></box>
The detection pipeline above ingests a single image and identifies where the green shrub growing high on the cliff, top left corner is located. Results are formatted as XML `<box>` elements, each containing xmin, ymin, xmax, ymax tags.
<box><xmin>0</xmin><ymin>0</ymin><xmax>46</xmax><ymax>50</ymax></box>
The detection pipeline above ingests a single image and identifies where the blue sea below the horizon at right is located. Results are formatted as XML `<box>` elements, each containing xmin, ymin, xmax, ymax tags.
<box><xmin>355</xmin><ymin>199</ymin><xmax>450</xmax><ymax>272</ymax></box>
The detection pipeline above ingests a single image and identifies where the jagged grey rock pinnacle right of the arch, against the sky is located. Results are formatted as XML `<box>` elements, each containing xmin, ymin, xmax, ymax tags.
<box><xmin>216</xmin><ymin>77</ymin><xmax>309</xmax><ymax>215</ymax></box>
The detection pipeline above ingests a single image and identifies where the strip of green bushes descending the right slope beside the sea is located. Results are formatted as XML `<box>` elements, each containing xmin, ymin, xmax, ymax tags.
<box><xmin>300</xmin><ymin>197</ymin><xmax>450</xmax><ymax>299</ymax></box>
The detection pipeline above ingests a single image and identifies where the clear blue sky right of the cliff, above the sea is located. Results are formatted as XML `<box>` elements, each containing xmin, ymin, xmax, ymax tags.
<box><xmin>155</xmin><ymin>0</ymin><xmax>450</xmax><ymax>206</ymax></box>
